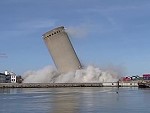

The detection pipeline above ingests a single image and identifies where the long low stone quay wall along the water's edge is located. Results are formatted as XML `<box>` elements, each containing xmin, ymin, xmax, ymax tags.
<box><xmin>0</xmin><ymin>81</ymin><xmax>138</xmax><ymax>88</ymax></box>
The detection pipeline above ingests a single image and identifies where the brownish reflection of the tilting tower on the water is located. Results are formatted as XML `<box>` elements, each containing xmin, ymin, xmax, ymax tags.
<box><xmin>52</xmin><ymin>88</ymin><xmax>79</xmax><ymax>113</ymax></box>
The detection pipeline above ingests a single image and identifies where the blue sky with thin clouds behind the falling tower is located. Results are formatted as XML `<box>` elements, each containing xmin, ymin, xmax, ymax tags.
<box><xmin>0</xmin><ymin>0</ymin><xmax>150</xmax><ymax>75</ymax></box>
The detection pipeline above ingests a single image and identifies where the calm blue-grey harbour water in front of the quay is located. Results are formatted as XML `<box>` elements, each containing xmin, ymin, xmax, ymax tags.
<box><xmin>0</xmin><ymin>87</ymin><xmax>150</xmax><ymax>113</ymax></box>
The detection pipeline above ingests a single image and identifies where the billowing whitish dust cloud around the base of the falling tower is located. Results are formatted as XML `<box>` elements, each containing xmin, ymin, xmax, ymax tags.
<box><xmin>23</xmin><ymin>66</ymin><xmax>119</xmax><ymax>83</ymax></box>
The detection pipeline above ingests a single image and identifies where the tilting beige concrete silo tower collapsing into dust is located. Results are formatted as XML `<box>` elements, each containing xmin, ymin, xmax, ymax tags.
<box><xmin>43</xmin><ymin>26</ymin><xmax>81</xmax><ymax>73</ymax></box>
